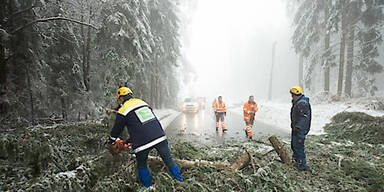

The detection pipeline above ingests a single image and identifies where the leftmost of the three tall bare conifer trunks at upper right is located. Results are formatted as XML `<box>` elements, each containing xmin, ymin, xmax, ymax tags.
<box><xmin>323</xmin><ymin>0</ymin><xmax>331</xmax><ymax>94</ymax></box>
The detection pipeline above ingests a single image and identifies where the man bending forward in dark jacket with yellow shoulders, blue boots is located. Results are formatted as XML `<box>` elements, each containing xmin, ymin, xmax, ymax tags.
<box><xmin>109</xmin><ymin>87</ymin><xmax>183</xmax><ymax>187</ymax></box>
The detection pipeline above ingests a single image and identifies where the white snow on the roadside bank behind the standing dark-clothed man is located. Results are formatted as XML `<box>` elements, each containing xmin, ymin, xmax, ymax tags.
<box><xmin>231</xmin><ymin>101</ymin><xmax>384</xmax><ymax>135</ymax></box>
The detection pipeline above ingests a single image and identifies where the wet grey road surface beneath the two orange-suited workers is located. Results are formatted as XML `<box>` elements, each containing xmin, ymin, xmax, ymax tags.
<box><xmin>166</xmin><ymin>110</ymin><xmax>289</xmax><ymax>145</ymax></box>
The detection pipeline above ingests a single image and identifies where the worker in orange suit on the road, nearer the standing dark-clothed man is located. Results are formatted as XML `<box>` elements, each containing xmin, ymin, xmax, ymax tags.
<box><xmin>243</xmin><ymin>95</ymin><xmax>258</xmax><ymax>139</ymax></box>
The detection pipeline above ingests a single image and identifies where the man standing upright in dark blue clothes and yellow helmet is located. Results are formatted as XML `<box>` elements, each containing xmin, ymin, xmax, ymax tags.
<box><xmin>290</xmin><ymin>86</ymin><xmax>312</xmax><ymax>170</ymax></box>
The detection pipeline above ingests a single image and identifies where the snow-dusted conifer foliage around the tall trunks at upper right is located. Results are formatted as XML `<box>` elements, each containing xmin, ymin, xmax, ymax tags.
<box><xmin>292</xmin><ymin>0</ymin><xmax>384</xmax><ymax>97</ymax></box>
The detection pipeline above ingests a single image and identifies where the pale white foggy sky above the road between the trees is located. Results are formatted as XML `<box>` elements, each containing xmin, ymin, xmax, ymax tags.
<box><xmin>184</xmin><ymin>0</ymin><xmax>298</xmax><ymax>102</ymax></box>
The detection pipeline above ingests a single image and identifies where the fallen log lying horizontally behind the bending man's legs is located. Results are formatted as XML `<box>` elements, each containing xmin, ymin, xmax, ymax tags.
<box><xmin>148</xmin><ymin>153</ymin><xmax>251</xmax><ymax>172</ymax></box>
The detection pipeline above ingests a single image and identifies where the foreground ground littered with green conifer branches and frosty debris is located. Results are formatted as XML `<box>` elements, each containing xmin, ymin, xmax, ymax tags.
<box><xmin>0</xmin><ymin>112</ymin><xmax>384</xmax><ymax>191</ymax></box>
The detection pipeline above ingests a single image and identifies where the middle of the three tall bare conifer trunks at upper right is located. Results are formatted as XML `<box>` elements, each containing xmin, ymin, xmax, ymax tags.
<box><xmin>337</xmin><ymin>1</ymin><xmax>348</xmax><ymax>96</ymax></box>
